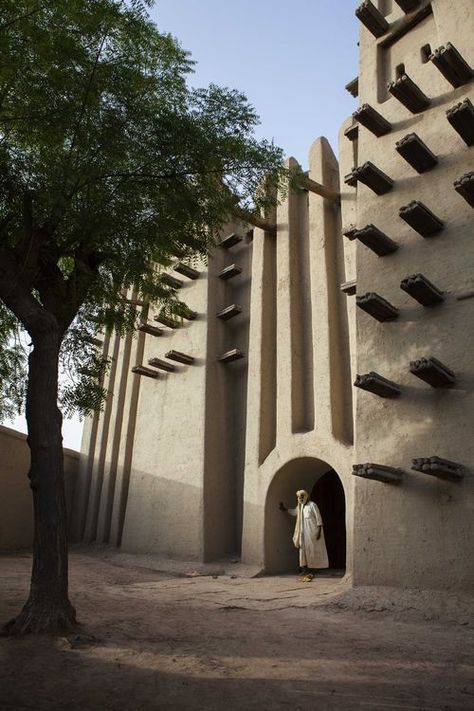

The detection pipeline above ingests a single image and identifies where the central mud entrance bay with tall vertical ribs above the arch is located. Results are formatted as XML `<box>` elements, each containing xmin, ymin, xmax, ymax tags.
<box><xmin>242</xmin><ymin>139</ymin><xmax>353</xmax><ymax>573</ymax></box>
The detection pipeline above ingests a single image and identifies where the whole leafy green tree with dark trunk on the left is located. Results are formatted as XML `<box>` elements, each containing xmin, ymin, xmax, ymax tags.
<box><xmin>0</xmin><ymin>0</ymin><xmax>282</xmax><ymax>634</ymax></box>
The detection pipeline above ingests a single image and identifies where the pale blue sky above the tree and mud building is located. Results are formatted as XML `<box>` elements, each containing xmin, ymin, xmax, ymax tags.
<box><xmin>4</xmin><ymin>0</ymin><xmax>360</xmax><ymax>449</ymax></box>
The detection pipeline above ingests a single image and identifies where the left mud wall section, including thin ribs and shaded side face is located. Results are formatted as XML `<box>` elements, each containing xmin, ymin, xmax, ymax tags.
<box><xmin>72</xmin><ymin>223</ymin><xmax>252</xmax><ymax>560</ymax></box>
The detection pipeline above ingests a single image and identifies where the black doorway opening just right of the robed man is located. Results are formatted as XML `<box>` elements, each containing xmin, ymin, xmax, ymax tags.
<box><xmin>311</xmin><ymin>469</ymin><xmax>346</xmax><ymax>570</ymax></box>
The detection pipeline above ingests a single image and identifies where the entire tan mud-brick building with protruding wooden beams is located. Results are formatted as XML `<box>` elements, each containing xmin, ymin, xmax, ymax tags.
<box><xmin>71</xmin><ymin>0</ymin><xmax>474</xmax><ymax>590</ymax></box>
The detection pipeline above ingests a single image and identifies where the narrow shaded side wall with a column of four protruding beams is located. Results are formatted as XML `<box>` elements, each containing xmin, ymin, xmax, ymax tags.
<box><xmin>203</xmin><ymin>222</ymin><xmax>253</xmax><ymax>560</ymax></box>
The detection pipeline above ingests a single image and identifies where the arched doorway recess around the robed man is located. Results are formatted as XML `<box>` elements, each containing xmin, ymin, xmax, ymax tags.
<box><xmin>264</xmin><ymin>457</ymin><xmax>346</xmax><ymax>575</ymax></box>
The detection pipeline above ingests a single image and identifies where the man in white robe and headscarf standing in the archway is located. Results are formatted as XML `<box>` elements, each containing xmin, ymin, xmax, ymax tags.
<box><xmin>279</xmin><ymin>489</ymin><xmax>329</xmax><ymax>582</ymax></box>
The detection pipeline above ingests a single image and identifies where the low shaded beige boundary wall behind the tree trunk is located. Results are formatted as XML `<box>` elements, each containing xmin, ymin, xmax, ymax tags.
<box><xmin>0</xmin><ymin>425</ymin><xmax>79</xmax><ymax>550</ymax></box>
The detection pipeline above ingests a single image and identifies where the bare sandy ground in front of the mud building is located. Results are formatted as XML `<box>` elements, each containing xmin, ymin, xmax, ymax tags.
<box><xmin>0</xmin><ymin>551</ymin><xmax>474</xmax><ymax>711</ymax></box>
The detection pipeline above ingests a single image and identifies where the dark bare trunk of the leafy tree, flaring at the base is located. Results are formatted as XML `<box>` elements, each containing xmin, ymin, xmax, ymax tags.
<box><xmin>4</xmin><ymin>323</ymin><xmax>77</xmax><ymax>634</ymax></box>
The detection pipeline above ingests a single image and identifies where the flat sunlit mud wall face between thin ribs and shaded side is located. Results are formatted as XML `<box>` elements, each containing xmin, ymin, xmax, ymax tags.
<box><xmin>122</xmin><ymin>264</ymin><xmax>208</xmax><ymax>558</ymax></box>
